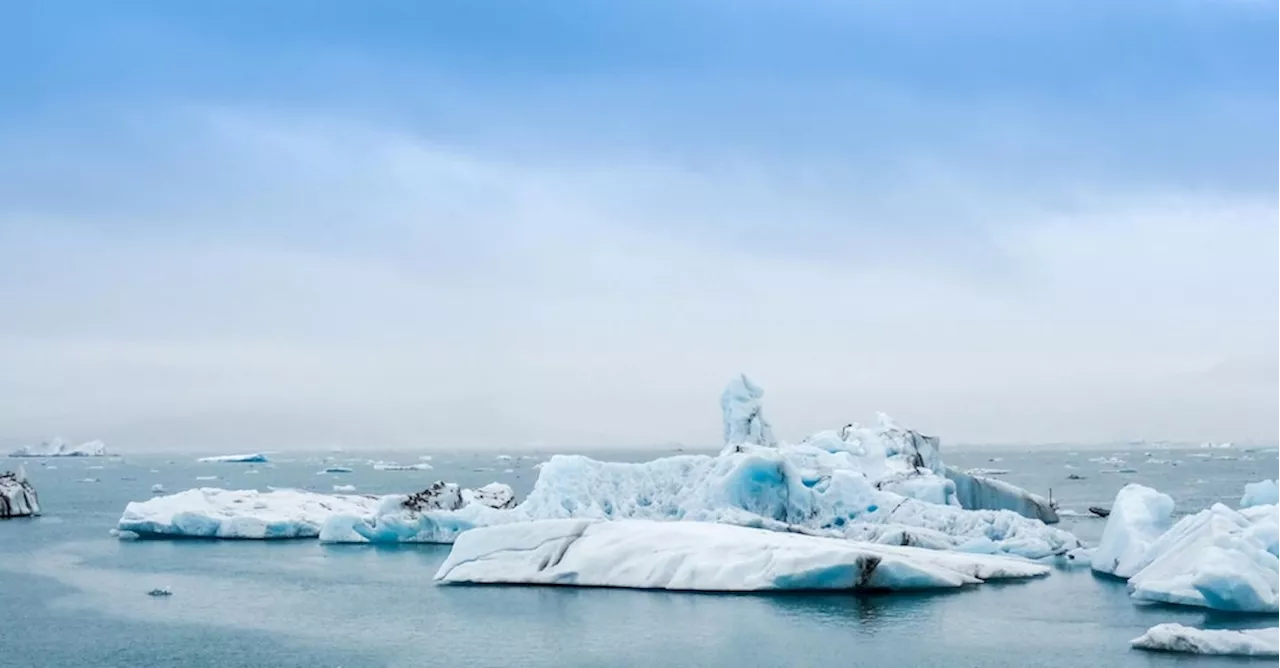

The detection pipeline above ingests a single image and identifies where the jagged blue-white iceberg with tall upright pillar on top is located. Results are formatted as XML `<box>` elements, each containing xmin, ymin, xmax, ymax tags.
<box><xmin>321</xmin><ymin>378</ymin><xmax>1080</xmax><ymax>558</ymax></box>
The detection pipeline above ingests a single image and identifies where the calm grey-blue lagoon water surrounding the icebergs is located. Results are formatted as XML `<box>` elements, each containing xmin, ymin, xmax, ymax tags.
<box><xmin>0</xmin><ymin>448</ymin><xmax>1280</xmax><ymax>668</ymax></box>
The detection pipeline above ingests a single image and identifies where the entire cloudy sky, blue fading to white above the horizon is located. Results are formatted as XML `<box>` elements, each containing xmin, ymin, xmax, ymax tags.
<box><xmin>0</xmin><ymin>0</ymin><xmax>1280</xmax><ymax>450</ymax></box>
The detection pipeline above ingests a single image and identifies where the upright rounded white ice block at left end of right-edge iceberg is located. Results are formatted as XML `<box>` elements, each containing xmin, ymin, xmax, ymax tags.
<box><xmin>1092</xmin><ymin>482</ymin><xmax>1174</xmax><ymax>578</ymax></box>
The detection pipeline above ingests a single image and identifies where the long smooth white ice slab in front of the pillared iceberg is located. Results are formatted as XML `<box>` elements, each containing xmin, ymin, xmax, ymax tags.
<box><xmin>435</xmin><ymin>520</ymin><xmax>1048</xmax><ymax>591</ymax></box>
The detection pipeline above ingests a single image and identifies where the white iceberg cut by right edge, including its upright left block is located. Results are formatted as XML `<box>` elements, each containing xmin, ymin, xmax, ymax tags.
<box><xmin>1093</xmin><ymin>485</ymin><xmax>1280</xmax><ymax>613</ymax></box>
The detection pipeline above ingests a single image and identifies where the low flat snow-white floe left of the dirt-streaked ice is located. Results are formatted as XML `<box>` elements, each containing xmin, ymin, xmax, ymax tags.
<box><xmin>116</xmin><ymin>488</ymin><xmax>378</xmax><ymax>539</ymax></box>
